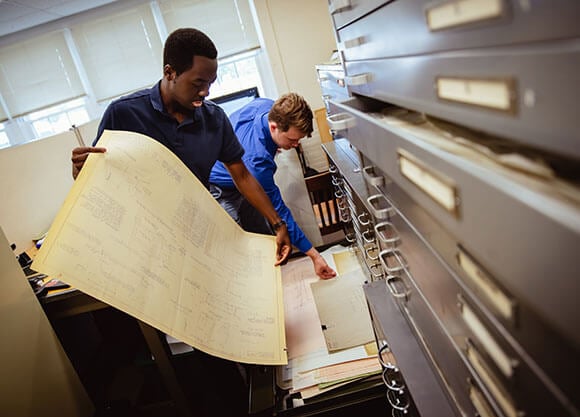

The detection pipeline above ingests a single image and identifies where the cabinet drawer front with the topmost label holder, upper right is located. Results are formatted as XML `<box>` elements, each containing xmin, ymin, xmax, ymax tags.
<box><xmin>337</xmin><ymin>0</ymin><xmax>580</xmax><ymax>61</ymax></box>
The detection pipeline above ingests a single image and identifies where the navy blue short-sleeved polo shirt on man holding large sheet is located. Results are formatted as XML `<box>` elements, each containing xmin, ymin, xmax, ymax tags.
<box><xmin>93</xmin><ymin>82</ymin><xmax>244</xmax><ymax>188</ymax></box>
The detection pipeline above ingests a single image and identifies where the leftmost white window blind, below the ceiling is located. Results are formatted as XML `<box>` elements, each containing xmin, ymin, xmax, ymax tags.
<box><xmin>0</xmin><ymin>32</ymin><xmax>85</xmax><ymax>117</ymax></box>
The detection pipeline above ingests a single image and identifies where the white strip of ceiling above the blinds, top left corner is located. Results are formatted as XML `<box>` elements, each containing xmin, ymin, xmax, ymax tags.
<box><xmin>0</xmin><ymin>0</ymin><xmax>116</xmax><ymax>37</ymax></box>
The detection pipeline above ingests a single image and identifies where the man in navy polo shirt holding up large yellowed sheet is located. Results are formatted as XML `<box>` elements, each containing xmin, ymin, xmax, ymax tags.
<box><xmin>72</xmin><ymin>29</ymin><xmax>291</xmax><ymax>265</ymax></box>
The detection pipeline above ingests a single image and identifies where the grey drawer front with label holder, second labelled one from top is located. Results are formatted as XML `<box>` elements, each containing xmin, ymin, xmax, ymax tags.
<box><xmin>346</xmin><ymin>41</ymin><xmax>580</xmax><ymax>158</ymax></box>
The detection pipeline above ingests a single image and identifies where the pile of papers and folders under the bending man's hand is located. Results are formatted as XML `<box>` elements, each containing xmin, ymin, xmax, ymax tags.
<box><xmin>277</xmin><ymin>246</ymin><xmax>381</xmax><ymax>400</ymax></box>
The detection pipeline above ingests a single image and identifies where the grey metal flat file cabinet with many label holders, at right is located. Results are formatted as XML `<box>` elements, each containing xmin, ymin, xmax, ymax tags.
<box><xmin>323</xmin><ymin>0</ymin><xmax>580</xmax><ymax>417</ymax></box>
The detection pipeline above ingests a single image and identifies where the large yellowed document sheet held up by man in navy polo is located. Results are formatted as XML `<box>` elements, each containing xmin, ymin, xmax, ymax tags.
<box><xmin>33</xmin><ymin>131</ymin><xmax>287</xmax><ymax>365</ymax></box>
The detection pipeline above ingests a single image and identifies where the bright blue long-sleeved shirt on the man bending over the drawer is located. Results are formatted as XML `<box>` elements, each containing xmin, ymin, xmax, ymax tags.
<box><xmin>209</xmin><ymin>98</ymin><xmax>312</xmax><ymax>252</ymax></box>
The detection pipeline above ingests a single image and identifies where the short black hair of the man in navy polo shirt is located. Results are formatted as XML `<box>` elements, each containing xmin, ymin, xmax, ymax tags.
<box><xmin>163</xmin><ymin>28</ymin><xmax>217</xmax><ymax>75</ymax></box>
